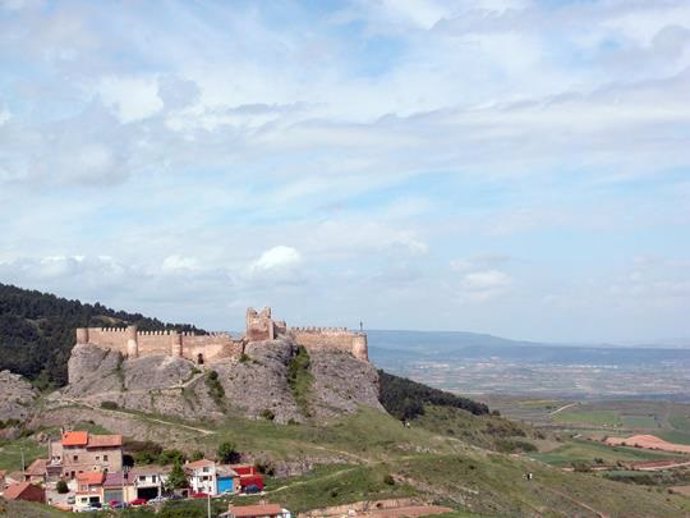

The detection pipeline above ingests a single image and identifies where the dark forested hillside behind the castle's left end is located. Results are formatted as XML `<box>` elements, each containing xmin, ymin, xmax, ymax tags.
<box><xmin>0</xmin><ymin>284</ymin><xmax>203</xmax><ymax>388</ymax></box>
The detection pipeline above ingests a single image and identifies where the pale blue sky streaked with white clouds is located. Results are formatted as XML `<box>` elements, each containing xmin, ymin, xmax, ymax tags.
<box><xmin>0</xmin><ymin>0</ymin><xmax>690</xmax><ymax>345</ymax></box>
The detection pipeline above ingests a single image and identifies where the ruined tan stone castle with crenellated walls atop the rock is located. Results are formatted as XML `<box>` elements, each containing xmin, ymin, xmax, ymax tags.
<box><xmin>76</xmin><ymin>307</ymin><xmax>369</xmax><ymax>363</ymax></box>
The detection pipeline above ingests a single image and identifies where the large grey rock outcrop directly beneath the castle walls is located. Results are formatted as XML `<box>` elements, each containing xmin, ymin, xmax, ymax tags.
<box><xmin>51</xmin><ymin>338</ymin><xmax>384</xmax><ymax>423</ymax></box>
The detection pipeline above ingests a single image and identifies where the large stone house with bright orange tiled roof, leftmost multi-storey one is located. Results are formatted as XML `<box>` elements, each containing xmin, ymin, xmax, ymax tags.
<box><xmin>49</xmin><ymin>432</ymin><xmax>122</xmax><ymax>479</ymax></box>
